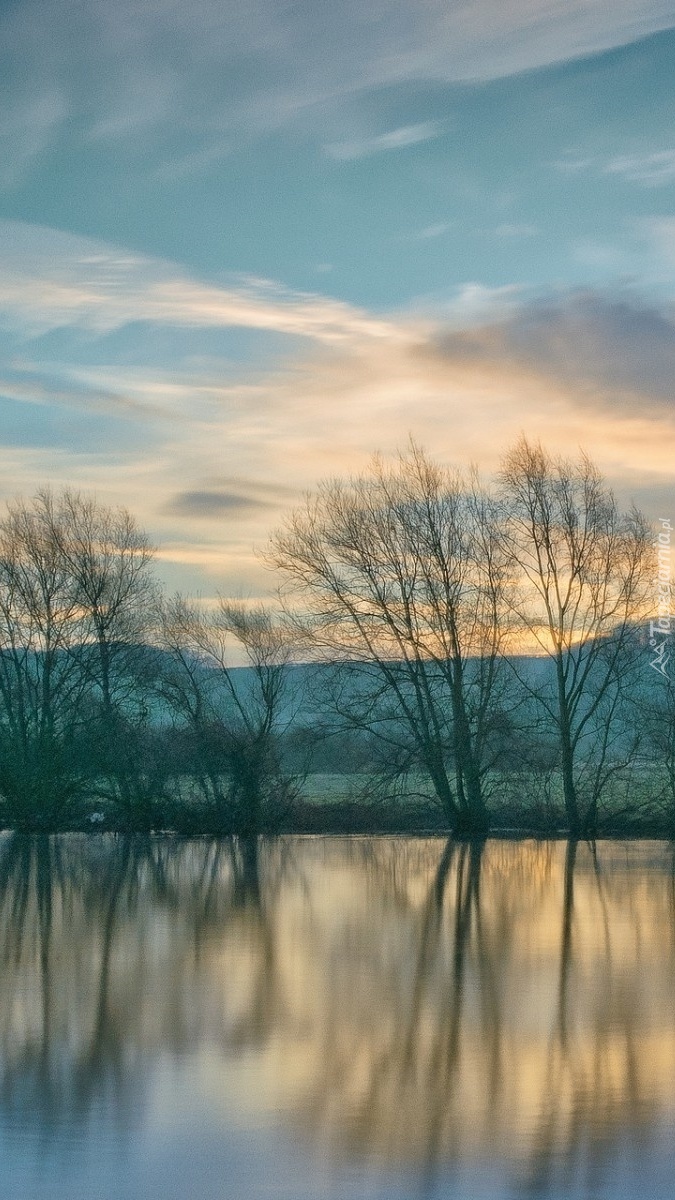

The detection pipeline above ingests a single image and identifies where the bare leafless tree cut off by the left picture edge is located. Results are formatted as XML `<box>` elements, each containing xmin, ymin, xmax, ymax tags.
<box><xmin>0</xmin><ymin>488</ymin><xmax>156</xmax><ymax>827</ymax></box>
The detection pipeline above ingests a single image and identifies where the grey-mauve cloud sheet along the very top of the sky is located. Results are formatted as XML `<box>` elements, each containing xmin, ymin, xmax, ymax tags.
<box><xmin>0</xmin><ymin>0</ymin><xmax>675</xmax><ymax>177</ymax></box>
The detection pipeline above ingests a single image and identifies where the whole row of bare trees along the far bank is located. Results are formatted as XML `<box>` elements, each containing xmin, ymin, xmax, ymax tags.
<box><xmin>0</xmin><ymin>438</ymin><xmax>662</xmax><ymax>836</ymax></box>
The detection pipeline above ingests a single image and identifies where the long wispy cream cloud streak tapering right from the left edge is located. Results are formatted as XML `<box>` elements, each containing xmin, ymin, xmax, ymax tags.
<box><xmin>0</xmin><ymin>221</ymin><xmax>410</xmax><ymax>343</ymax></box>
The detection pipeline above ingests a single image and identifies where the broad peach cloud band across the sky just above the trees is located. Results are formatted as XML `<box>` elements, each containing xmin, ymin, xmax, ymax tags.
<box><xmin>0</xmin><ymin>218</ymin><xmax>675</xmax><ymax>592</ymax></box>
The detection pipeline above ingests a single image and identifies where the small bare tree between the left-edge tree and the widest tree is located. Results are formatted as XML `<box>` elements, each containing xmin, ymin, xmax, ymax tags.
<box><xmin>161</xmin><ymin>596</ymin><xmax>297</xmax><ymax>836</ymax></box>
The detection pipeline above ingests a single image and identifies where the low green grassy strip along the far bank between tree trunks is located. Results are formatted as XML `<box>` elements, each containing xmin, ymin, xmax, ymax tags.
<box><xmin>0</xmin><ymin>763</ymin><xmax>675</xmax><ymax>838</ymax></box>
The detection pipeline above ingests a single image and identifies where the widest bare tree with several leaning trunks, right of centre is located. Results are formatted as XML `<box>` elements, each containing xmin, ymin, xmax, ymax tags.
<box><xmin>269</xmin><ymin>444</ymin><xmax>507</xmax><ymax>835</ymax></box>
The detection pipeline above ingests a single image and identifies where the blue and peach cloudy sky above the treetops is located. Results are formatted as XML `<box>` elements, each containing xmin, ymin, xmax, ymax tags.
<box><xmin>0</xmin><ymin>0</ymin><xmax>675</xmax><ymax>596</ymax></box>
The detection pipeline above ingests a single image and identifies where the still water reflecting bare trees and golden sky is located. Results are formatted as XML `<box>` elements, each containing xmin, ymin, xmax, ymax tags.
<box><xmin>0</xmin><ymin>834</ymin><xmax>675</xmax><ymax>1200</ymax></box>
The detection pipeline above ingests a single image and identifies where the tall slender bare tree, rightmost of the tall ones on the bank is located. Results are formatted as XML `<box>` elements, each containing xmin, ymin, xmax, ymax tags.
<box><xmin>501</xmin><ymin>438</ymin><xmax>653</xmax><ymax>836</ymax></box>
